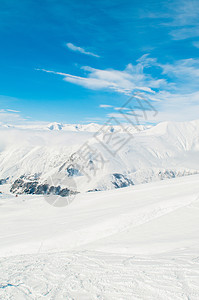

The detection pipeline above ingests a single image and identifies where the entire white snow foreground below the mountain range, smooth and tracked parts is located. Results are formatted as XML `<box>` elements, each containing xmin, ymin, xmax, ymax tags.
<box><xmin>0</xmin><ymin>175</ymin><xmax>199</xmax><ymax>300</ymax></box>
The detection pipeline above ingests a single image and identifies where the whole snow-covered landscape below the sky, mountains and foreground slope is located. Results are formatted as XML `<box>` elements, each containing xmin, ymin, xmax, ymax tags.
<box><xmin>0</xmin><ymin>121</ymin><xmax>199</xmax><ymax>300</ymax></box>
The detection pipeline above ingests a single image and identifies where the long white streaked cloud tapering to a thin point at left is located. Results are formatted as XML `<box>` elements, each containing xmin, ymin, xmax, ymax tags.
<box><xmin>37</xmin><ymin>61</ymin><xmax>163</xmax><ymax>95</ymax></box>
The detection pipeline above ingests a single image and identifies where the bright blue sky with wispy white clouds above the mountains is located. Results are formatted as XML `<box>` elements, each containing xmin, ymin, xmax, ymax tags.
<box><xmin>0</xmin><ymin>0</ymin><xmax>199</xmax><ymax>123</ymax></box>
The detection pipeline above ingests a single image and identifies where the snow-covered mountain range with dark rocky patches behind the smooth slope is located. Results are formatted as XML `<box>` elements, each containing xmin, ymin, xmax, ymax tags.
<box><xmin>0</xmin><ymin>120</ymin><xmax>199</xmax><ymax>196</ymax></box>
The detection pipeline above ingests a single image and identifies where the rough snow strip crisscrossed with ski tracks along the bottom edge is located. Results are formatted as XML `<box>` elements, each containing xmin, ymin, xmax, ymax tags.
<box><xmin>0</xmin><ymin>251</ymin><xmax>199</xmax><ymax>300</ymax></box>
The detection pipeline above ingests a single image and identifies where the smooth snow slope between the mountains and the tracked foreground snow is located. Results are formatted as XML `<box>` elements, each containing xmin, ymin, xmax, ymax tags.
<box><xmin>0</xmin><ymin>175</ymin><xmax>199</xmax><ymax>255</ymax></box>
